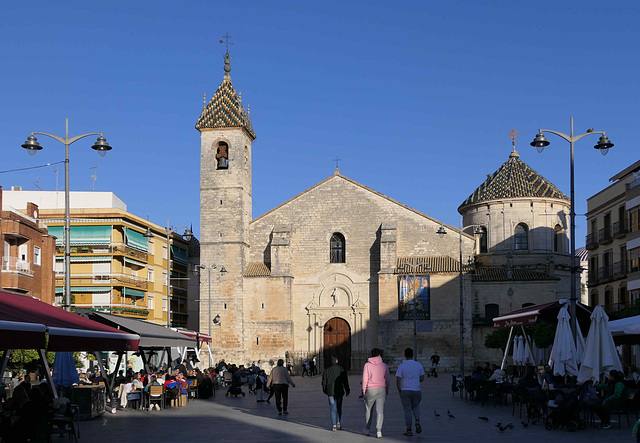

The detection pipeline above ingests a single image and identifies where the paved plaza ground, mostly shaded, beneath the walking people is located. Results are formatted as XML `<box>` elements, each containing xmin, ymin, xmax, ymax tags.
<box><xmin>79</xmin><ymin>374</ymin><xmax>635</xmax><ymax>443</ymax></box>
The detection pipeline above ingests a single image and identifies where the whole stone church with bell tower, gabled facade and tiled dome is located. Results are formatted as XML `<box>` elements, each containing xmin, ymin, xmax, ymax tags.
<box><xmin>196</xmin><ymin>54</ymin><xmax>569</xmax><ymax>370</ymax></box>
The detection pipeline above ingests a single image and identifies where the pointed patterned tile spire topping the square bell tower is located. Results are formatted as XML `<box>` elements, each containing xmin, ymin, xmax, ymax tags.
<box><xmin>196</xmin><ymin>52</ymin><xmax>256</xmax><ymax>140</ymax></box>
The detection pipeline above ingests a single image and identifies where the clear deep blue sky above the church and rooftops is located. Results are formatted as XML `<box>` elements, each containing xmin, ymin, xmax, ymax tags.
<box><xmin>0</xmin><ymin>0</ymin><xmax>640</xmax><ymax>246</ymax></box>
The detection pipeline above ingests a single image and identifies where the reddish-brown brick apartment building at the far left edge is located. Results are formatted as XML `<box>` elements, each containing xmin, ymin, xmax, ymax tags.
<box><xmin>0</xmin><ymin>186</ymin><xmax>54</xmax><ymax>304</ymax></box>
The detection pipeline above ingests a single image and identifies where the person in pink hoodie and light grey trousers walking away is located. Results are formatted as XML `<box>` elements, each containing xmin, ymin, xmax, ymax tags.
<box><xmin>362</xmin><ymin>348</ymin><xmax>391</xmax><ymax>438</ymax></box>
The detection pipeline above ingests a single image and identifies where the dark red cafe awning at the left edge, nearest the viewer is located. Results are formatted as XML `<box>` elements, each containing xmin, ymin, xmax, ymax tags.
<box><xmin>0</xmin><ymin>292</ymin><xmax>140</xmax><ymax>351</ymax></box>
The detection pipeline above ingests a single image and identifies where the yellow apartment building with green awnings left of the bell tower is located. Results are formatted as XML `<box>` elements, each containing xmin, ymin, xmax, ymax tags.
<box><xmin>5</xmin><ymin>190</ymin><xmax>190</xmax><ymax>327</ymax></box>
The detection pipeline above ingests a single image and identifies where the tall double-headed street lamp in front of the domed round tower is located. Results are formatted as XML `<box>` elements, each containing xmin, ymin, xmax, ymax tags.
<box><xmin>530</xmin><ymin>117</ymin><xmax>613</xmax><ymax>342</ymax></box>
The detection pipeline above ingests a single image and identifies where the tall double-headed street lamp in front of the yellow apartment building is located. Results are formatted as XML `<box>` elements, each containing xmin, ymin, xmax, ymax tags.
<box><xmin>21</xmin><ymin>118</ymin><xmax>111</xmax><ymax>311</ymax></box>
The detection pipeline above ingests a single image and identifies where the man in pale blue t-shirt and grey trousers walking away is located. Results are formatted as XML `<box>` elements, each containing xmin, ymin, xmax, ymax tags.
<box><xmin>396</xmin><ymin>348</ymin><xmax>425</xmax><ymax>437</ymax></box>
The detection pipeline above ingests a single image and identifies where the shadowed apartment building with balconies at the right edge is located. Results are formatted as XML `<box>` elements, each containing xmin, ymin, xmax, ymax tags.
<box><xmin>586</xmin><ymin>161</ymin><xmax>640</xmax><ymax>312</ymax></box>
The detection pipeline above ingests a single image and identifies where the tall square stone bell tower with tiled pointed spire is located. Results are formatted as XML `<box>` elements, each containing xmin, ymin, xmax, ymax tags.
<box><xmin>196</xmin><ymin>52</ymin><xmax>256</xmax><ymax>363</ymax></box>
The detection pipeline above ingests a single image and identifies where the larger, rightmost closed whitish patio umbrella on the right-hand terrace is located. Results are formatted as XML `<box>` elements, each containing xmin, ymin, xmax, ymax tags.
<box><xmin>578</xmin><ymin>306</ymin><xmax>622</xmax><ymax>383</ymax></box>
